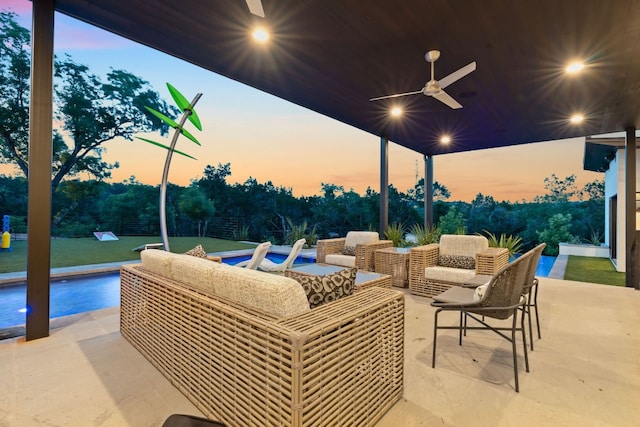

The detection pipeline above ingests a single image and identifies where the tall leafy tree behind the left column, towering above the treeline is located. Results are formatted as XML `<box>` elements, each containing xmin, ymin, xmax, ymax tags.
<box><xmin>0</xmin><ymin>12</ymin><xmax>174</xmax><ymax>191</ymax></box>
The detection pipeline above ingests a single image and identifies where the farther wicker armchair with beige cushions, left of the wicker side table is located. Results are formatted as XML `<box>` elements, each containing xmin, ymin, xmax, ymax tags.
<box><xmin>316</xmin><ymin>231</ymin><xmax>393</xmax><ymax>271</ymax></box>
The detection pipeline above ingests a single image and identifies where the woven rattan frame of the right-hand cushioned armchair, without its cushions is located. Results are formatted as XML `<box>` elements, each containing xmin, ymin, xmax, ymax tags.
<box><xmin>409</xmin><ymin>243</ymin><xmax>509</xmax><ymax>298</ymax></box>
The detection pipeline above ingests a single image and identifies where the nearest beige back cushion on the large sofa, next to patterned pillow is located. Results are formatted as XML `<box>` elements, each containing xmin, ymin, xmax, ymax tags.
<box><xmin>211</xmin><ymin>264</ymin><xmax>310</xmax><ymax>317</ymax></box>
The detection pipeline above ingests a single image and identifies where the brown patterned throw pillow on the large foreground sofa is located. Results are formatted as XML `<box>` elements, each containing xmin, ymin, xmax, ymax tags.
<box><xmin>296</xmin><ymin>267</ymin><xmax>358</xmax><ymax>308</ymax></box>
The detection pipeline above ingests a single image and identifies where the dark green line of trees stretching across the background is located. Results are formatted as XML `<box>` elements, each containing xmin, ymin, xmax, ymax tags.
<box><xmin>0</xmin><ymin>163</ymin><xmax>604</xmax><ymax>254</ymax></box>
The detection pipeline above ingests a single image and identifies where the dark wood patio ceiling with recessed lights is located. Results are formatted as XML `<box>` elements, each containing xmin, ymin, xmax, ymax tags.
<box><xmin>55</xmin><ymin>0</ymin><xmax>640</xmax><ymax>155</ymax></box>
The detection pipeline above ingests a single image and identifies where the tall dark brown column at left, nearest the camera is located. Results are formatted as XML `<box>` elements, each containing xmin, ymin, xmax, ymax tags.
<box><xmin>26</xmin><ymin>0</ymin><xmax>55</xmax><ymax>341</ymax></box>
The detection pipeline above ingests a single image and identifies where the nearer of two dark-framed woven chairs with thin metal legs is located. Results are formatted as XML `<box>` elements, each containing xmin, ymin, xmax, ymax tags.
<box><xmin>431</xmin><ymin>247</ymin><xmax>534</xmax><ymax>392</ymax></box>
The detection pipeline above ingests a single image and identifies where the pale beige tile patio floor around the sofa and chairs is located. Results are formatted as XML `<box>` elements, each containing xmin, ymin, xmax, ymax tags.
<box><xmin>0</xmin><ymin>278</ymin><xmax>640</xmax><ymax>427</ymax></box>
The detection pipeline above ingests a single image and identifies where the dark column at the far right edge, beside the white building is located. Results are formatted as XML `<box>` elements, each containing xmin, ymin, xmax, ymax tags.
<box><xmin>624</xmin><ymin>127</ymin><xmax>640</xmax><ymax>290</ymax></box>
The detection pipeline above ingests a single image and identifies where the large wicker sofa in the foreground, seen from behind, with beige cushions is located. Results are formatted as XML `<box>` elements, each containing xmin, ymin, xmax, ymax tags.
<box><xmin>120</xmin><ymin>251</ymin><xmax>404</xmax><ymax>427</ymax></box>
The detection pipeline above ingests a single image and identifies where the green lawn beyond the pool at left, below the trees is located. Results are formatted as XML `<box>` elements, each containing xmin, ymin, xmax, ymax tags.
<box><xmin>0</xmin><ymin>236</ymin><xmax>255</xmax><ymax>273</ymax></box>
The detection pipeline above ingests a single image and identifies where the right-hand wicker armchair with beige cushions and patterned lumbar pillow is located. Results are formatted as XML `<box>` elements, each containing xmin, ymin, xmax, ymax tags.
<box><xmin>409</xmin><ymin>234</ymin><xmax>509</xmax><ymax>297</ymax></box>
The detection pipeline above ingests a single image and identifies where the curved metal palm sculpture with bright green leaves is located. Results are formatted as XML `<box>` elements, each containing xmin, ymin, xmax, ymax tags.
<box><xmin>136</xmin><ymin>83</ymin><xmax>202</xmax><ymax>252</ymax></box>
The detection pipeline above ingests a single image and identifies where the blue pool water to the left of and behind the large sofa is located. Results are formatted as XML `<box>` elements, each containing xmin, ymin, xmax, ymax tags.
<box><xmin>0</xmin><ymin>253</ymin><xmax>315</xmax><ymax>329</ymax></box>
